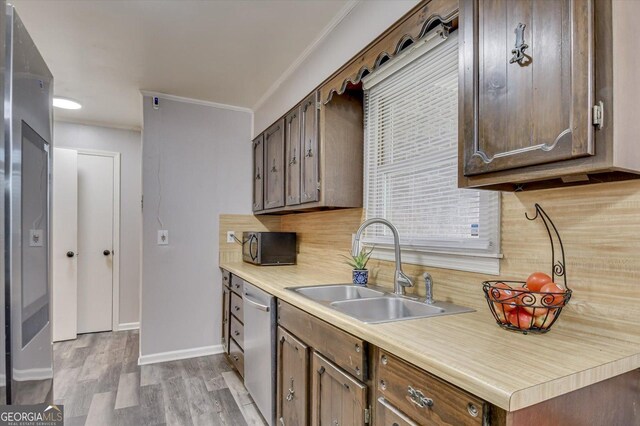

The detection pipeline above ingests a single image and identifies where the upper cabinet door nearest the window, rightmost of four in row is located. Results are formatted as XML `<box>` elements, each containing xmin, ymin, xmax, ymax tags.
<box><xmin>300</xmin><ymin>93</ymin><xmax>320</xmax><ymax>203</ymax></box>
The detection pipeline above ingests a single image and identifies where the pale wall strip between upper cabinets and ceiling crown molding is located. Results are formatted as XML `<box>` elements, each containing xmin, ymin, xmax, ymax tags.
<box><xmin>254</xmin><ymin>0</ymin><xmax>419</xmax><ymax>135</ymax></box>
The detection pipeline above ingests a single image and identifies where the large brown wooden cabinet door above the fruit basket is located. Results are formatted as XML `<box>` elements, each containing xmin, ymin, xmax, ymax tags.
<box><xmin>459</xmin><ymin>0</ymin><xmax>595</xmax><ymax>176</ymax></box>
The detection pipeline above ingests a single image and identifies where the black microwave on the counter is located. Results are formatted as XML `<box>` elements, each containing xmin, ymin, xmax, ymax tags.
<box><xmin>242</xmin><ymin>232</ymin><xmax>296</xmax><ymax>265</ymax></box>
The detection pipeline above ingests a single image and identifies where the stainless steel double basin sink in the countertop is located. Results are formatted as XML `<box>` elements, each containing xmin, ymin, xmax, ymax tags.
<box><xmin>289</xmin><ymin>284</ymin><xmax>473</xmax><ymax>324</ymax></box>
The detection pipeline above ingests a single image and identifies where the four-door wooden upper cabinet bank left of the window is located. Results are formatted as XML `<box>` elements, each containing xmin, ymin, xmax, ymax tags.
<box><xmin>254</xmin><ymin>90</ymin><xmax>364</xmax><ymax>214</ymax></box>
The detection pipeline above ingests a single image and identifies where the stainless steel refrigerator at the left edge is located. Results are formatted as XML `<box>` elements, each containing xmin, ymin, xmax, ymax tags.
<box><xmin>0</xmin><ymin>0</ymin><xmax>53</xmax><ymax>404</ymax></box>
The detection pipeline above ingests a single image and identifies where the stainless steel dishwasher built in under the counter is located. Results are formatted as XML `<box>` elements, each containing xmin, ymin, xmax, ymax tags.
<box><xmin>243</xmin><ymin>281</ymin><xmax>277</xmax><ymax>426</ymax></box>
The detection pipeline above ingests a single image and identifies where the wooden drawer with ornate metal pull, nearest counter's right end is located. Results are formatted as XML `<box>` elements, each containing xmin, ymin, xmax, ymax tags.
<box><xmin>376</xmin><ymin>350</ymin><xmax>488</xmax><ymax>426</ymax></box>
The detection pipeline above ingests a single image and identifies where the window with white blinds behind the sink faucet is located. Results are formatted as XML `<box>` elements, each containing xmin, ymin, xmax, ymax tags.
<box><xmin>363</xmin><ymin>27</ymin><xmax>500</xmax><ymax>273</ymax></box>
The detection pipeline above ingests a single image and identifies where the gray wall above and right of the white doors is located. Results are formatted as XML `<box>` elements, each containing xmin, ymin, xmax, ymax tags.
<box><xmin>53</xmin><ymin>121</ymin><xmax>142</xmax><ymax>324</ymax></box>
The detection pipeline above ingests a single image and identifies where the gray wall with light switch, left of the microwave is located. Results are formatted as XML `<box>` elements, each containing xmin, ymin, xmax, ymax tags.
<box><xmin>140</xmin><ymin>97</ymin><xmax>252</xmax><ymax>356</ymax></box>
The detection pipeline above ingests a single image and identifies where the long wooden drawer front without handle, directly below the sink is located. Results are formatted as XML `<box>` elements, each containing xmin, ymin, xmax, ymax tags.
<box><xmin>278</xmin><ymin>301</ymin><xmax>368</xmax><ymax>381</ymax></box>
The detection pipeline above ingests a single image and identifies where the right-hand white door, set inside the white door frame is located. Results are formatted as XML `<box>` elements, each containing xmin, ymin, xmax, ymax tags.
<box><xmin>78</xmin><ymin>152</ymin><xmax>115</xmax><ymax>333</ymax></box>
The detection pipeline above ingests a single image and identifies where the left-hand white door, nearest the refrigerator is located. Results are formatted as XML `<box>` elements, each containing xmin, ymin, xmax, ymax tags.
<box><xmin>51</xmin><ymin>148</ymin><xmax>78</xmax><ymax>342</ymax></box>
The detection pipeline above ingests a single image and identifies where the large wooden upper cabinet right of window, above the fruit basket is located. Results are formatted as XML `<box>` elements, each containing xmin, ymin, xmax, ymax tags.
<box><xmin>458</xmin><ymin>0</ymin><xmax>640</xmax><ymax>191</ymax></box>
